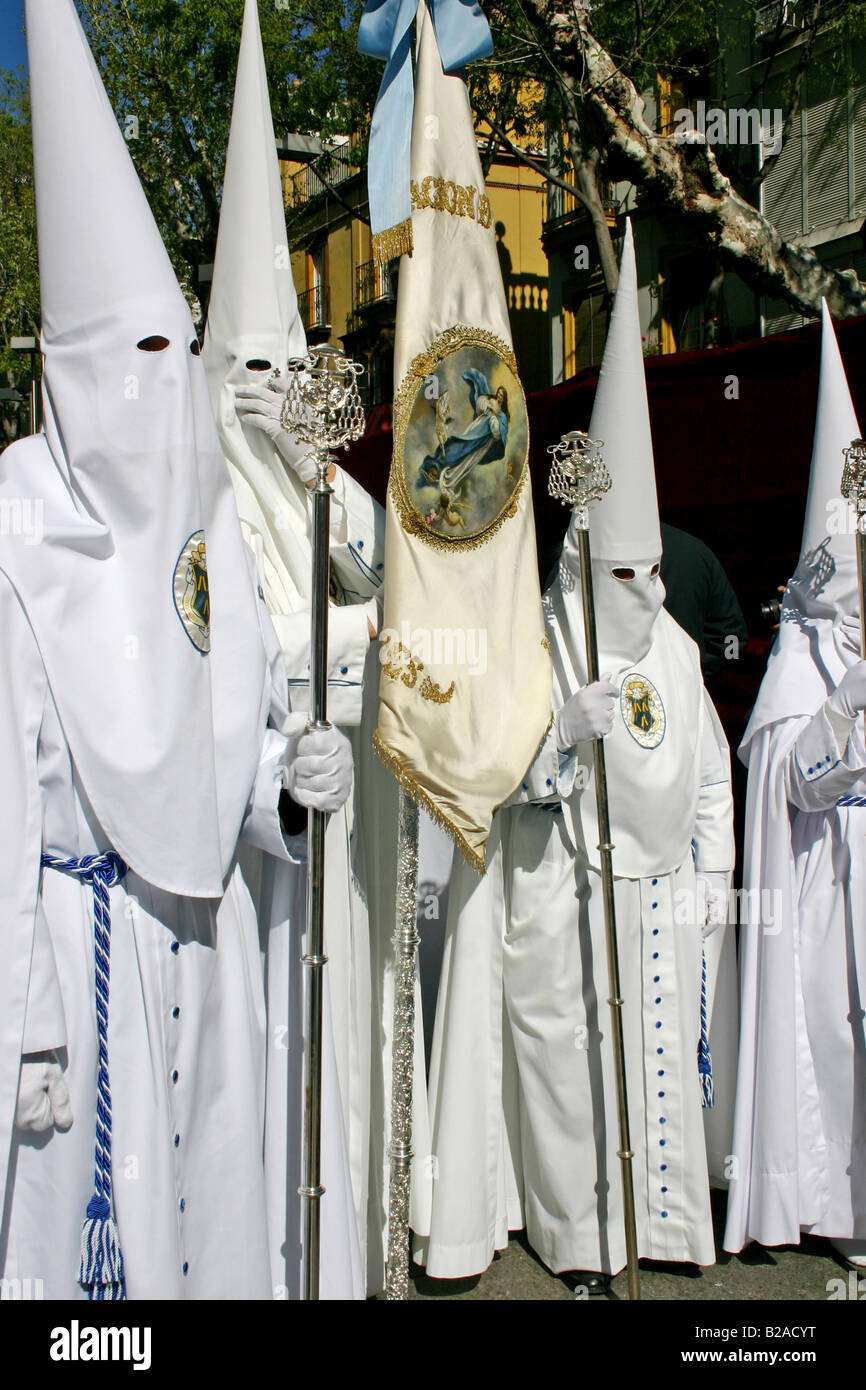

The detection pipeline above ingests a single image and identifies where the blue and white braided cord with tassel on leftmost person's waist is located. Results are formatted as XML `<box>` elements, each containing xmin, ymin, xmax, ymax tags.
<box><xmin>42</xmin><ymin>851</ymin><xmax>126</xmax><ymax>1301</ymax></box>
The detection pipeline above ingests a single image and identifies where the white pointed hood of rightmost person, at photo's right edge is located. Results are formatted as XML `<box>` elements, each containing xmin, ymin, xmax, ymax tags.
<box><xmin>740</xmin><ymin>300</ymin><xmax>860</xmax><ymax>760</ymax></box>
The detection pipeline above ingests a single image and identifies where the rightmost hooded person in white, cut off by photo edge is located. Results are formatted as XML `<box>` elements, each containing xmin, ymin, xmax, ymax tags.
<box><xmin>724</xmin><ymin>306</ymin><xmax>866</xmax><ymax>1250</ymax></box>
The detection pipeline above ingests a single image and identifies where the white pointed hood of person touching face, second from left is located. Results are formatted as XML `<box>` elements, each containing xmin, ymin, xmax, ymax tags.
<box><xmin>202</xmin><ymin>0</ymin><xmax>310</xmax><ymax>614</ymax></box>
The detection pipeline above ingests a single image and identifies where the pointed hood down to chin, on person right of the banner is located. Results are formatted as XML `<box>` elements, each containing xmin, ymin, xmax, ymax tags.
<box><xmin>560</xmin><ymin>221</ymin><xmax>664</xmax><ymax>673</ymax></box>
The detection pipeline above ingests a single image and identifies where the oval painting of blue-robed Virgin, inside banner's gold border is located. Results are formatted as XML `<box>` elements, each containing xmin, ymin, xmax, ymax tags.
<box><xmin>403</xmin><ymin>343</ymin><xmax>528</xmax><ymax>541</ymax></box>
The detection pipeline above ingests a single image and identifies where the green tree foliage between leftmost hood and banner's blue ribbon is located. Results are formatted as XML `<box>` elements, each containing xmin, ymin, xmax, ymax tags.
<box><xmin>76</xmin><ymin>0</ymin><xmax>381</xmax><ymax>304</ymax></box>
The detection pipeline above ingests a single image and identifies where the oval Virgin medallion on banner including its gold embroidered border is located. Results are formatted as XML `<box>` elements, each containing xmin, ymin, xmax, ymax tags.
<box><xmin>391</xmin><ymin>327</ymin><xmax>530</xmax><ymax>549</ymax></box>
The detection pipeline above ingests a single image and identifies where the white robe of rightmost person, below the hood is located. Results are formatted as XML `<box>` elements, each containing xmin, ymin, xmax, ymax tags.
<box><xmin>724</xmin><ymin>700</ymin><xmax>866</xmax><ymax>1251</ymax></box>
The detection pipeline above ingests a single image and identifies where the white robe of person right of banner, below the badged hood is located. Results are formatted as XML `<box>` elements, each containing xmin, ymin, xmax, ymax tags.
<box><xmin>417</xmin><ymin>650</ymin><xmax>735</xmax><ymax>1277</ymax></box>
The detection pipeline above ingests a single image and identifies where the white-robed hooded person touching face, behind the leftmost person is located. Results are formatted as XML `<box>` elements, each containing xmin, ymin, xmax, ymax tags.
<box><xmin>203</xmin><ymin>0</ymin><xmax>424</xmax><ymax>1297</ymax></box>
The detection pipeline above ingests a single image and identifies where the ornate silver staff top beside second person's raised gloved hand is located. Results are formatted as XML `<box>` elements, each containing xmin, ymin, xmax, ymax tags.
<box><xmin>279</xmin><ymin>345</ymin><xmax>364</xmax><ymax>482</ymax></box>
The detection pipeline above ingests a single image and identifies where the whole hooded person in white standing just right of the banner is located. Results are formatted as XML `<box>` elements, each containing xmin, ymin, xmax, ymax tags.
<box><xmin>417</xmin><ymin>228</ymin><xmax>734</xmax><ymax>1277</ymax></box>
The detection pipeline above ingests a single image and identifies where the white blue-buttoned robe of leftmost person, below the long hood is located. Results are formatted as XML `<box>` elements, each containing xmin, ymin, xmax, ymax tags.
<box><xmin>0</xmin><ymin>561</ymin><xmax>288</xmax><ymax>1298</ymax></box>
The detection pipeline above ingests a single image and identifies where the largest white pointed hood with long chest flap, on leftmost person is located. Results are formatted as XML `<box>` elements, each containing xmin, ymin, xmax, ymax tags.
<box><xmin>0</xmin><ymin>0</ymin><xmax>264</xmax><ymax>897</ymax></box>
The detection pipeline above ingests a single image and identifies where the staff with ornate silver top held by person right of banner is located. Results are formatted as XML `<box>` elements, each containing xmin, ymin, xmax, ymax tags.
<box><xmin>549</xmin><ymin>430</ymin><xmax>641</xmax><ymax>1300</ymax></box>
